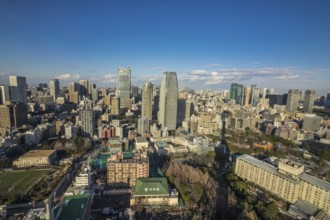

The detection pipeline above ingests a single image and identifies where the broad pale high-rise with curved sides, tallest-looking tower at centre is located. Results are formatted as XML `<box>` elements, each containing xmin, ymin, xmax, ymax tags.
<box><xmin>158</xmin><ymin>72</ymin><xmax>178</xmax><ymax>130</ymax></box>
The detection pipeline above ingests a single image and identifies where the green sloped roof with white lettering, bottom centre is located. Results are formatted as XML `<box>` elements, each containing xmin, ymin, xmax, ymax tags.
<box><xmin>134</xmin><ymin>177</ymin><xmax>170</xmax><ymax>196</ymax></box>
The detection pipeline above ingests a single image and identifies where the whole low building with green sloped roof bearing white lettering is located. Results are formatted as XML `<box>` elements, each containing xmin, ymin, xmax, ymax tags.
<box><xmin>131</xmin><ymin>177</ymin><xmax>179</xmax><ymax>206</ymax></box>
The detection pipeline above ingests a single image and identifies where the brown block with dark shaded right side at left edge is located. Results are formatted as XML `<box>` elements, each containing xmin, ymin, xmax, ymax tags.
<box><xmin>0</xmin><ymin>102</ymin><xmax>28</xmax><ymax>133</ymax></box>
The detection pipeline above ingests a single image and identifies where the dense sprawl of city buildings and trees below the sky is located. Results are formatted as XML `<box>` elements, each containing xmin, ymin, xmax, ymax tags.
<box><xmin>0</xmin><ymin>67</ymin><xmax>330</xmax><ymax>220</ymax></box>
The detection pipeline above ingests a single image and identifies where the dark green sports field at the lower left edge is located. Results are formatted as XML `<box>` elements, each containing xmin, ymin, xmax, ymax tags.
<box><xmin>0</xmin><ymin>170</ymin><xmax>48</xmax><ymax>194</ymax></box>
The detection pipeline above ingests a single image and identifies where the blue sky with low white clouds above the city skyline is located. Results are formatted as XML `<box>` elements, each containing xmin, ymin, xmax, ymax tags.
<box><xmin>0</xmin><ymin>0</ymin><xmax>330</xmax><ymax>95</ymax></box>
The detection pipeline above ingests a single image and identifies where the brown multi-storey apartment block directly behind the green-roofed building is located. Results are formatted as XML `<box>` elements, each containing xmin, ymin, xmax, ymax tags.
<box><xmin>107</xmin><ymin>153</ymin><xmax>149</xmax><ymax>187</ymax></box>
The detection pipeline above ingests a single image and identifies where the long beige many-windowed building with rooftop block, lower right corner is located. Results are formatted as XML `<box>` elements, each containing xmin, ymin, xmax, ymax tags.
<box><xmin>235</xmin><ymin>155</ymin><xmax>330</xmax><ymax>213</ymax></box>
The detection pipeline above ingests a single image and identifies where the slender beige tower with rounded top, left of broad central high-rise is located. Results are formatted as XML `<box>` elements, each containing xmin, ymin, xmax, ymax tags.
<box><xmin>141</xmin><ymin>82</ymin><xmax>153</xmax><ymax>120</ymax></box>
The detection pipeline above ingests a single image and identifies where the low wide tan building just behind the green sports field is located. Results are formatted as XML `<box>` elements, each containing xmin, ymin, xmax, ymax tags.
<box><xmin>13</xmin><ymin>150</ymin><xmax>57</xmax><ymax>167</ymax></box>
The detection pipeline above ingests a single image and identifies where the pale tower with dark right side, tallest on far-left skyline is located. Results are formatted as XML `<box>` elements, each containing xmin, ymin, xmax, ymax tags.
<box><xmin>9</xmin><ymin>76</ymin><xmax>27</xmax><ymax>104</ymax></box>
